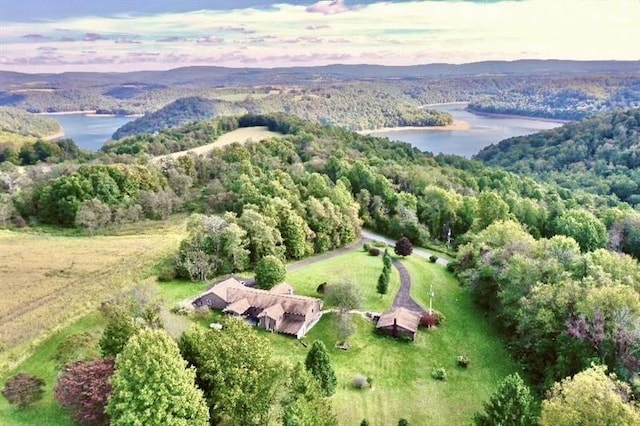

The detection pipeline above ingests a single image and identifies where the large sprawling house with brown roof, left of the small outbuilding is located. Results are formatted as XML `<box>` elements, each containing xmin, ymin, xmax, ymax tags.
<box><xmin>193</xmin><ymin>278</ymin><xmax>322</xmax><ymax>339</ymax></box>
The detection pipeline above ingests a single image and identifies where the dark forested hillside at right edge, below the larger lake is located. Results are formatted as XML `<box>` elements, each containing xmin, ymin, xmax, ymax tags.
<box><xmin>476</xmin><ymin>109</ymin><xmax>640</xmax><ymax>204</ymax></box>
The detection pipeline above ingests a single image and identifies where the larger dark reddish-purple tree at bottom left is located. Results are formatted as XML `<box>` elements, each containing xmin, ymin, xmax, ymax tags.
<box><xmin>54</xmin><ymin>358</ymin><xmax>114</xmax><ymax>425</ymax></box>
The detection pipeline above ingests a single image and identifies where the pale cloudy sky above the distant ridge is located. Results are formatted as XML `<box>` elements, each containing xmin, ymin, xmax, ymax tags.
<box><xmin>0</xmin><ymin>0</ymin><xmax>640</xmax><ymax>72</ymax></box>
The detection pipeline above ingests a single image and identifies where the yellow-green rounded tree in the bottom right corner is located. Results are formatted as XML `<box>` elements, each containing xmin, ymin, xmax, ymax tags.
<box><xmin>541</xmin><ymin>365</ymin><xmax>640</xmax><ymax>426</ymax></box>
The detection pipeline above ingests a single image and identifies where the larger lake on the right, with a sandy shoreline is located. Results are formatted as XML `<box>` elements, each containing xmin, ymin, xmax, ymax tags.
<box><xmin>371</xmin><ymin>103</ymin><xmax>563</xmax><ymax>158</ymax></box>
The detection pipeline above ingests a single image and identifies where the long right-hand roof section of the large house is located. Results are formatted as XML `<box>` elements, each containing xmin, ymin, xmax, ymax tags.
<box><xmin>227</xmin><ymin>287</ymin><xmax>320</xmax><ymax>315</ymax></box>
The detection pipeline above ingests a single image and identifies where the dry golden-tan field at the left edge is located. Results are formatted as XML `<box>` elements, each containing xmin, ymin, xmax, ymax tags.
<box><xmin>0</xmin><ymin>223</ymin><xmax>184</xmax><ymax>370</ymax></box>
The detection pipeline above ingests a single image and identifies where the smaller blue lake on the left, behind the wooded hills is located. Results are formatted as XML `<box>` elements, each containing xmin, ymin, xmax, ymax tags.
<box><xmin>43</xmin><ymin>113</ymin><xmax>135</xmax><ymax>151</ymax></box>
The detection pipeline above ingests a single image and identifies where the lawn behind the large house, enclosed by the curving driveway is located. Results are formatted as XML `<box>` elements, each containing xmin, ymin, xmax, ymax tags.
<box><xmin>285</xmin><ymin>250</ymin><xmax>400</xmax><ymax>312</ymax></box>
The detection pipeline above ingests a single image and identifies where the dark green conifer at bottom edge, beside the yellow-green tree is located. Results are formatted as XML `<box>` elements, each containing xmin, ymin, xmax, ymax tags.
<box><xmin>473</xmin><ymin>373</ymin><xmax>537</xmax><ymax>426</ymax></box>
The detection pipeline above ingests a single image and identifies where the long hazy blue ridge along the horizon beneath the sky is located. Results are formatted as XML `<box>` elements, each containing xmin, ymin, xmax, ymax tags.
<box><xmin>0</xmin><ymin>59</ymin><xmax>640</xmax><ymax>87</ymax></box>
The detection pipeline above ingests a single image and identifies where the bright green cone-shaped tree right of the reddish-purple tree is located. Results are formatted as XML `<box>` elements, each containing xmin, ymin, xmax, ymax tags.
<box><xmin>106</xmin><ymin>329</ymin><xmax>209</xmax><ymax>426</ymax></box>
